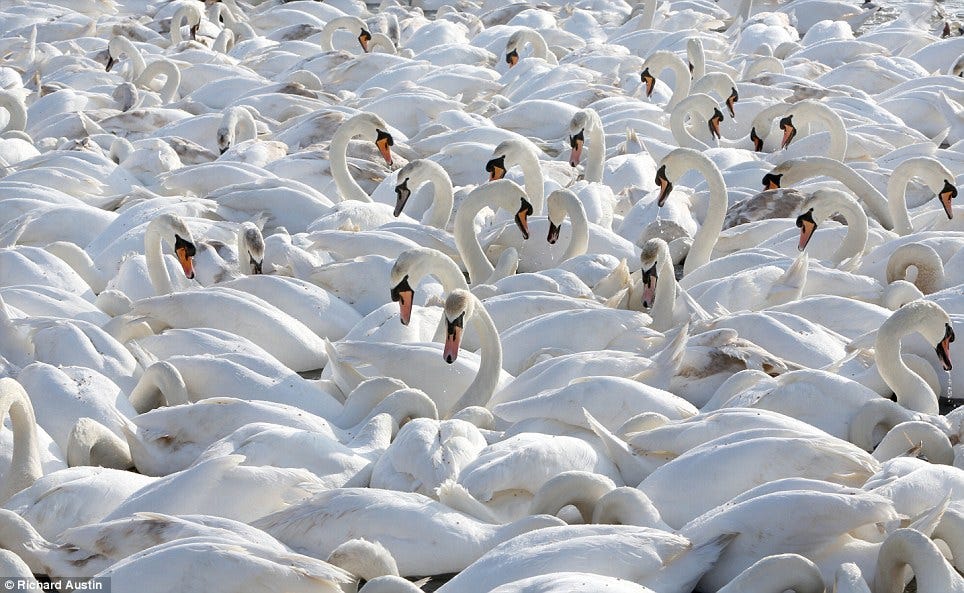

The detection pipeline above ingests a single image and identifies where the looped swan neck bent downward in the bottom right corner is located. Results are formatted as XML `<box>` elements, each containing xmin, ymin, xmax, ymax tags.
<box><xmin>874</xmin><ymin>528</ymin><xmax>964</xmax><ymax>593</ymax></box>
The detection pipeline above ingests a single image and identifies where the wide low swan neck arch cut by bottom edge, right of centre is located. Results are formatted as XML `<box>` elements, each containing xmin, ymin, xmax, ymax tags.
<box><xmin>717</xmin><ymin>554</ymin><xmax>824</xmax><ymax>593</ymax></box>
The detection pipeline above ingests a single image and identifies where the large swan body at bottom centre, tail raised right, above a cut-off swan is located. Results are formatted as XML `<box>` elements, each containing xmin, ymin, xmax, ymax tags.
<box><xmin>439</xmin><ymin>525</ymin><xmax>732</xmax><ymax>593</ymax></box>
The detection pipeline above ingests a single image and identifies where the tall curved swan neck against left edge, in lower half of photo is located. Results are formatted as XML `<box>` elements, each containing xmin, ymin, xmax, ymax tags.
<box><xmin>0</xmin><ymin>378</ymin><xmax>43</xmax><ymax>503</ymax></box>
